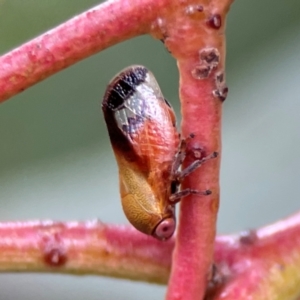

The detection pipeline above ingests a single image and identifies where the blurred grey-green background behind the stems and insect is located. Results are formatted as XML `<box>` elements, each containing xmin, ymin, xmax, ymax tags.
<box><xmin>0</xmin><ymin>0</ymin><xmax>300</xmax><ymax>300</ymax></box>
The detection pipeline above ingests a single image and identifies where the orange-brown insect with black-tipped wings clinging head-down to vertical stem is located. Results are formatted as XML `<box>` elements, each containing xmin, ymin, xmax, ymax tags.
<box><xmin>102</xmin><ymin>65</ymin><xmax>216</xmax><ymax>240</ymax></box>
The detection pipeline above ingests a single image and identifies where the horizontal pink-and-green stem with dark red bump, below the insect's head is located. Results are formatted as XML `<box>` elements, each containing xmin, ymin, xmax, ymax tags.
<box><xmin>0</xmin><ymin>222</ymin><xmax>174</xmax><ymax>283</ymax></box>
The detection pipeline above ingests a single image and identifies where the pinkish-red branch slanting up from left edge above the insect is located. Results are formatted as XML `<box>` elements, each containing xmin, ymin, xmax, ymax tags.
<box><xmin>0</xmin><ymin>0</ymin><xmax>172</xmax><ymax>102</ymax></box>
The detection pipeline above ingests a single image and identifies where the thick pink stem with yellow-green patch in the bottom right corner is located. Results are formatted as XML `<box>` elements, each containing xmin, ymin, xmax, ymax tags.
<box><xmin>212</xmin><ymin>213</ymin><xmax>300</xmax><ymax>300</ymax></box>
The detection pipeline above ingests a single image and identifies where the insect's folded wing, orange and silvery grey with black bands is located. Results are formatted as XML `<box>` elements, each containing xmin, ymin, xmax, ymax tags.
<box><xmin>103</xmin><ymin>66</ymin><xmax>179</xmax><ymax>171</ymax></box>
